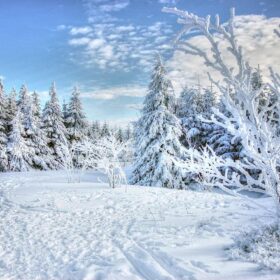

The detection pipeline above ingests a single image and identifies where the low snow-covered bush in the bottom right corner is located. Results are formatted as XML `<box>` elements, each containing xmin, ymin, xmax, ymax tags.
<box><xmin>229</xmin><ymin>224</ymin><xmax>280</xmax><ymax>271</ymax></box>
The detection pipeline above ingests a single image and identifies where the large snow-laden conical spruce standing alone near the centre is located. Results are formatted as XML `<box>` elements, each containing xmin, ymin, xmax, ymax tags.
<box><xmin>131</xmin><ymin>56</ymin><xmax>184</xmax><ymax>189</ymax></box>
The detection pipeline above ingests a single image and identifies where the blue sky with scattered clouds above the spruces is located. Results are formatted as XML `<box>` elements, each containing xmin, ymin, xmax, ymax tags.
<box><xmin>0</xmin><ymin>0</ymin><xmax>280</xmax><ymax>122</ymax></box>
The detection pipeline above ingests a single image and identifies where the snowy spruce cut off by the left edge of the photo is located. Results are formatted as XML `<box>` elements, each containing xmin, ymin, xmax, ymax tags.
<box><xmin>0</xmin><ymin>81</ymin><xmax>8</xmax><ymax>172</ymax></box>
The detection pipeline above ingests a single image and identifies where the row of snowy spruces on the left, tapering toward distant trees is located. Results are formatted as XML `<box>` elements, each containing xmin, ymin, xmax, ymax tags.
<box><xmin>0</xmin><ymin>82</ymin><xmax>132</xmax><ymax>172</ymax></box>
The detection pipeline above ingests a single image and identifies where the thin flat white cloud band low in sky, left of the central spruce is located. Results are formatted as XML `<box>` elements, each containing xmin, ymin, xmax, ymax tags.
<box><xmin>82</xmin><ymin>85</ymin><xmax>147</xmax><ymax>100</ymax></box>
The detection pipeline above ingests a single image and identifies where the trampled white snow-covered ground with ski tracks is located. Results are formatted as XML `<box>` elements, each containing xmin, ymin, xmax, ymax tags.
<box><xmin>0</xmin><ymin>171</ymin><xmax>280</xmax><ymax>280</ymax></box>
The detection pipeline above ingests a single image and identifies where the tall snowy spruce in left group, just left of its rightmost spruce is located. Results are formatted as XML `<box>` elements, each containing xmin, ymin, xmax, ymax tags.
<box><xmin>42</xmin><ymin>83</ymin><xmax>69</xmax><ymax>168</ymax></box>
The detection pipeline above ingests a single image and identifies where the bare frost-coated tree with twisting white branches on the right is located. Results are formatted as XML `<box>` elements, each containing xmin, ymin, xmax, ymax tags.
<box><xmin>164</xmin><ymin>8</ymin><xmax>280</xmax><ymax>219</ymax></box>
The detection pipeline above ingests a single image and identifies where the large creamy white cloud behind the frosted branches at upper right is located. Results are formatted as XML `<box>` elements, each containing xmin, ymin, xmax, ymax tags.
<box><xmin>167</xmin><ymin>15</ymin><xmax>280</xmax><ymax>94</ymax></box>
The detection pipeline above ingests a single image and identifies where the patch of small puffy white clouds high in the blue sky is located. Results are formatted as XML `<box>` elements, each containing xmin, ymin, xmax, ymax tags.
<box><xmin>68</xmin><ymin>21</ymin><xmax>172</xmax><ymax>71</ymax></box>
